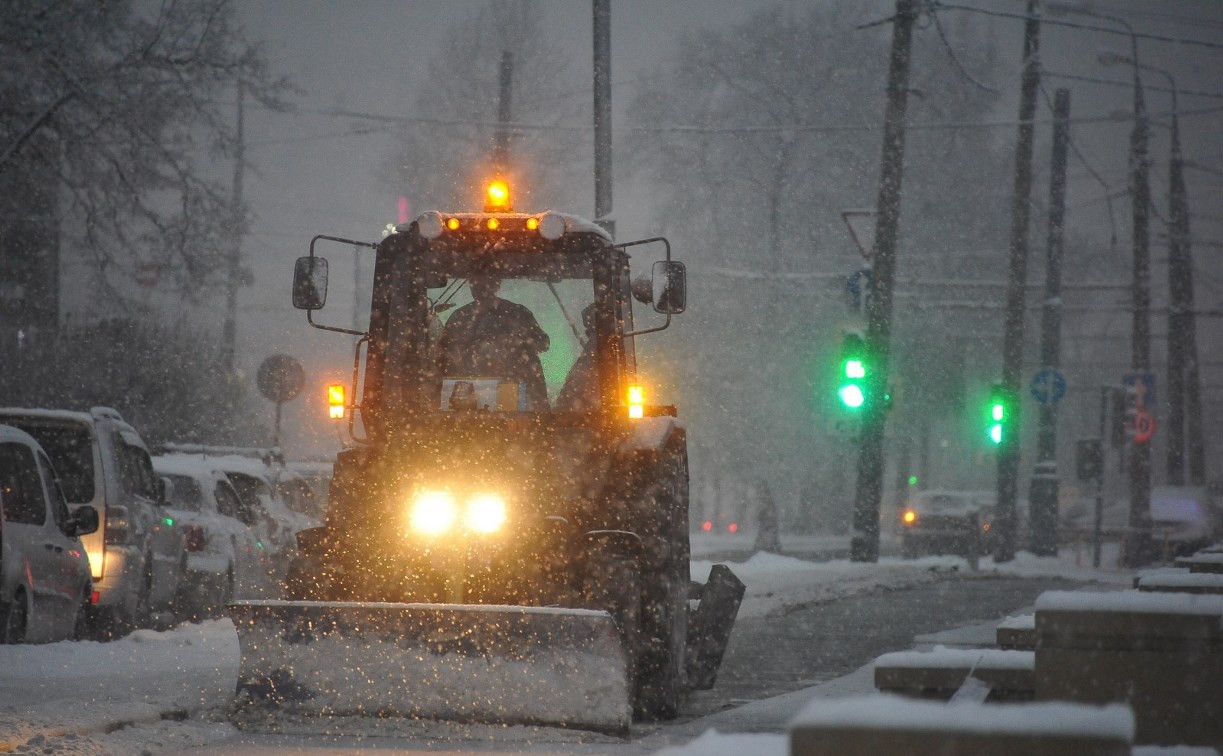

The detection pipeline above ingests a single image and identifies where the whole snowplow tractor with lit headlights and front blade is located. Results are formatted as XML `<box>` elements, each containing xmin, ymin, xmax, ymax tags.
<box><xmin>229</xmin><ymin>193</ymin><xmax>744</xmax><ymax>732</ymax></box>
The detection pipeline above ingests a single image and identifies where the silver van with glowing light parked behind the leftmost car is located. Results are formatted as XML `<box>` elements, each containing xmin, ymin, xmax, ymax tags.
<box><xmin>0</xmin><ymin>407</ymin><xmax>187</xmax><ymax>636</ymax></box>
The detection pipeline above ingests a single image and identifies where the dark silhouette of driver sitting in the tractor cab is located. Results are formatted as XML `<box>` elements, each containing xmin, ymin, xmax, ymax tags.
<box><xmin>439</xmin><ymin>274</ymin><xmax>549</xmax><ymax>410</ymax></box>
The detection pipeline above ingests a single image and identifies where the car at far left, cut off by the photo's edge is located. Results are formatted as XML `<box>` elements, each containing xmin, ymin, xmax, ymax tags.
<box><xmin>0</xmin><ymin>426</ymin><xmax>98</xmax><ymax>643</ymax></box>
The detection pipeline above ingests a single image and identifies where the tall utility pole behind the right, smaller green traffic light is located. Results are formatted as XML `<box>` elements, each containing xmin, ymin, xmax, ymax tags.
<box><xmin>994</xmin><ymin>0</ymin><xmax>1041</xmax><ymax>561</ymax></box>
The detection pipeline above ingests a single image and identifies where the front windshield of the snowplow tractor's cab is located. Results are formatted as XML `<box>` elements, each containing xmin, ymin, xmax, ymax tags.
<box><xmin>427</xmin><ymin>250</ymin><xmax>598</xmax><ymax>412</ymax></box>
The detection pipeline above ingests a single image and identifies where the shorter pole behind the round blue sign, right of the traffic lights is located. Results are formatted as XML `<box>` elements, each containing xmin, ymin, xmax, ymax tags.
<box><xmin>1030</xmin><ymin>89</ymin><xmax>1070</xmax><ymax>557</ymax></box>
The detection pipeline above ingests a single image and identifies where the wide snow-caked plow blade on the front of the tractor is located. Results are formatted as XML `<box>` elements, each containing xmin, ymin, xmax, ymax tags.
<box><xmin>229</xmin><ymin>601</ymin><xmax>632</xmax><ymax>733</ymax></box>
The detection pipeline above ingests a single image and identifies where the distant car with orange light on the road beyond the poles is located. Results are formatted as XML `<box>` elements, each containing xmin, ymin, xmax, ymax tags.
<box><xmin>900</xmin><ymin>491</ymin><xmax>992</xmax><ymax>559</ymax></box>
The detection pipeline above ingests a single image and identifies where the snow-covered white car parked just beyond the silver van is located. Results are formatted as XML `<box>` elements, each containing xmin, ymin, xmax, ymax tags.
<box><xmin>153</xmin><ymin>455</ymin><xmax>265</xmax><ymax>617</ymax></box>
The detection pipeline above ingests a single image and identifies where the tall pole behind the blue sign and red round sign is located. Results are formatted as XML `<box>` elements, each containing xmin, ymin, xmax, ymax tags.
<box><xmin>1125</xmin><ymin>50</ymin><xmax>1151</xmax><ymax>566</ymax></box>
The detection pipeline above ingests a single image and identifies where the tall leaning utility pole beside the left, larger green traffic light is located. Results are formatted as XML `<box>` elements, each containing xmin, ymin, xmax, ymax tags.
<box><xmin>850</xmin><ymin>0</ymin><xmax>917</xmax><ymax>561</ymax></box>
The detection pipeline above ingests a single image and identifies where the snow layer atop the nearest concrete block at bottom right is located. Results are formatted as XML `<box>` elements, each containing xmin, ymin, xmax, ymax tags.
<box><xmin>791</xmin><ymin>695</ymin><xmax>1134</xmax><ymax>740</ymax></box>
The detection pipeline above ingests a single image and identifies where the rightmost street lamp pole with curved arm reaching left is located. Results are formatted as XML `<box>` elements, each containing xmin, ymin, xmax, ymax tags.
<box><xmin>1099</xmin><ymin>53</ymin><xmax>1206</xmax><ymax>486</ymax></box>
